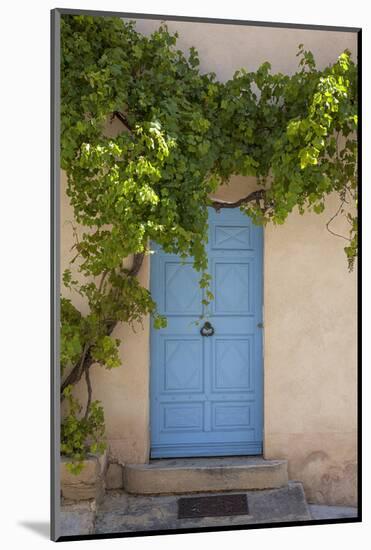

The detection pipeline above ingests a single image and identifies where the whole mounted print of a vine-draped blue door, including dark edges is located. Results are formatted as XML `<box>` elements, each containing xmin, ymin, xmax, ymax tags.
<box><xmin>51</xmin><ymin>9</ymin><xmax>362</xmax><ymax>541</ymax></box>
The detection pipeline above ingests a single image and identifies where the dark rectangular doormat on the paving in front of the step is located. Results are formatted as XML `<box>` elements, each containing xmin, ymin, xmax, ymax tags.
<box><xmin>178</xmin><ymin>494</ymin><xmax>249</xmax><ymax>519</ymax></box>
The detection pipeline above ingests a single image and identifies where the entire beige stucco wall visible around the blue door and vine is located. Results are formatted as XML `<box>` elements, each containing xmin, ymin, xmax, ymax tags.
<box><xmin>61</xmin><ymin>21</ymin><xmax>356</xmax><ymax>504</ymax></box>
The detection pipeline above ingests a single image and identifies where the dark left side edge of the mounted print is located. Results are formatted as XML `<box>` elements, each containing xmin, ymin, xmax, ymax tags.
<box><xmin>50</xmin><ymin>9</ymin><xmax>60</xmax><ymax>541</ymax></box>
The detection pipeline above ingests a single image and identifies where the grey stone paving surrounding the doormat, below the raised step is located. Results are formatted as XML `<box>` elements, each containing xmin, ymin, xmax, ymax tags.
<box><xmin>61</xmin><ymin>490</ymin><xmax>357</xmax><ymax>535</ymax></box>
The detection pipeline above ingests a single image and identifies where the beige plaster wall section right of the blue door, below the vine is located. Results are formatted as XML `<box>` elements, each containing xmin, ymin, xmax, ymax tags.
<box><xmin>264</xmin><ymin>197</ymin><xmax>357</xmax><ymax>504</ymax></box>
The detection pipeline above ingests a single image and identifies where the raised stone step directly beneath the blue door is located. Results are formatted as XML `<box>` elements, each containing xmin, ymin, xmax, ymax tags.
<box><xmin>124</xmin><ymin>456</ymin><xmax>288</xmax><ymax>495</ymax></box>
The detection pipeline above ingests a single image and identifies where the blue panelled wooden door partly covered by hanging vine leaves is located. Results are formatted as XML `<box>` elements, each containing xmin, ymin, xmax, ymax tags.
<box><xmin>150</xmin><ymin>208</ymin><xmax>263</xmax><ymax>458</ymax></box>
